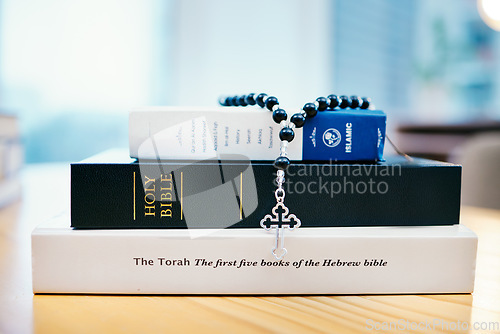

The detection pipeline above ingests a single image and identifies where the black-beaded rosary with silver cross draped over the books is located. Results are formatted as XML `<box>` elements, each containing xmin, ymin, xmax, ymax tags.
<box><xmin>219</xmin><ymin>93</ymin><xmax>370</xmax><ymax>260</ymax></box>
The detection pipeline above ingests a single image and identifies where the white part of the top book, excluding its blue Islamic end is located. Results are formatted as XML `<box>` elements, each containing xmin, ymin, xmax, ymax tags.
<box><xmin>129</xmin><ymin>107</ymin><xmax>303</xmax><ymax>160</ymax></box>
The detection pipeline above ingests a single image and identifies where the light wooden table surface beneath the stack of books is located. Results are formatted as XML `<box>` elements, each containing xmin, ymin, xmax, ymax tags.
<box><xmin>0</xmin><ymin>164</ymin><xmax>500</xmax><ymax>333</ymax></box>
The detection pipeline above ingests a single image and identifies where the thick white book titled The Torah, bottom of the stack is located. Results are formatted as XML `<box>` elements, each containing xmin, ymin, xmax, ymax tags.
<box><xmin>32</xmin><ymin>215</ymin><xmax>477</xmax><ymax>295</ymax></box>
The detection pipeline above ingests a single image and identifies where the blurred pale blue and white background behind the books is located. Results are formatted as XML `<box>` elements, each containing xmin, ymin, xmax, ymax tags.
<box><xmin>0</xmin><ymin>0</ymin><xmax>500</xmax><ymax>205</ymax></box>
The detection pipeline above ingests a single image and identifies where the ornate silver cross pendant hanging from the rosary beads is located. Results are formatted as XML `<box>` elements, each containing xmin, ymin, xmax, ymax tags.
<box><xmin>260</xmin><ymin>170</ymin><xmax>301</xmax><ymax>260</ymax></box>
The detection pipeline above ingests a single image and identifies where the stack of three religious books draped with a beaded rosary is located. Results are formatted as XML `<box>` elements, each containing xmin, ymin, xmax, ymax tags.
<box><xmin>32</xmin><ymin>108</ymin><xmax>477</xmax><ymax>294</ymax></box>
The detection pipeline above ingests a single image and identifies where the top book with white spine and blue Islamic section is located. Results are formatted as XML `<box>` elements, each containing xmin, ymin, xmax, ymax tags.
<box><xmin>129</xmin><ymin>108</ymin><xmax>386</xmax><ymax>161</ymax></box>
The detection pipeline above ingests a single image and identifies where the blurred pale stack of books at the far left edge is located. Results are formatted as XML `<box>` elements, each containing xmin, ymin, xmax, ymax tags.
<box><xmin>0</xmin><ymin>114</ymin><xmax>24</xmax><ymax>207</ymax></box>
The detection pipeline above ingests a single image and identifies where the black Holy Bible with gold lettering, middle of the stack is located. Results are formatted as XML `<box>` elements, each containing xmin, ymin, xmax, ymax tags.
<box><xmin>71</xmin><ymin>152</ymin><xmax>461</xmax><ymax>229</ymax></box>
